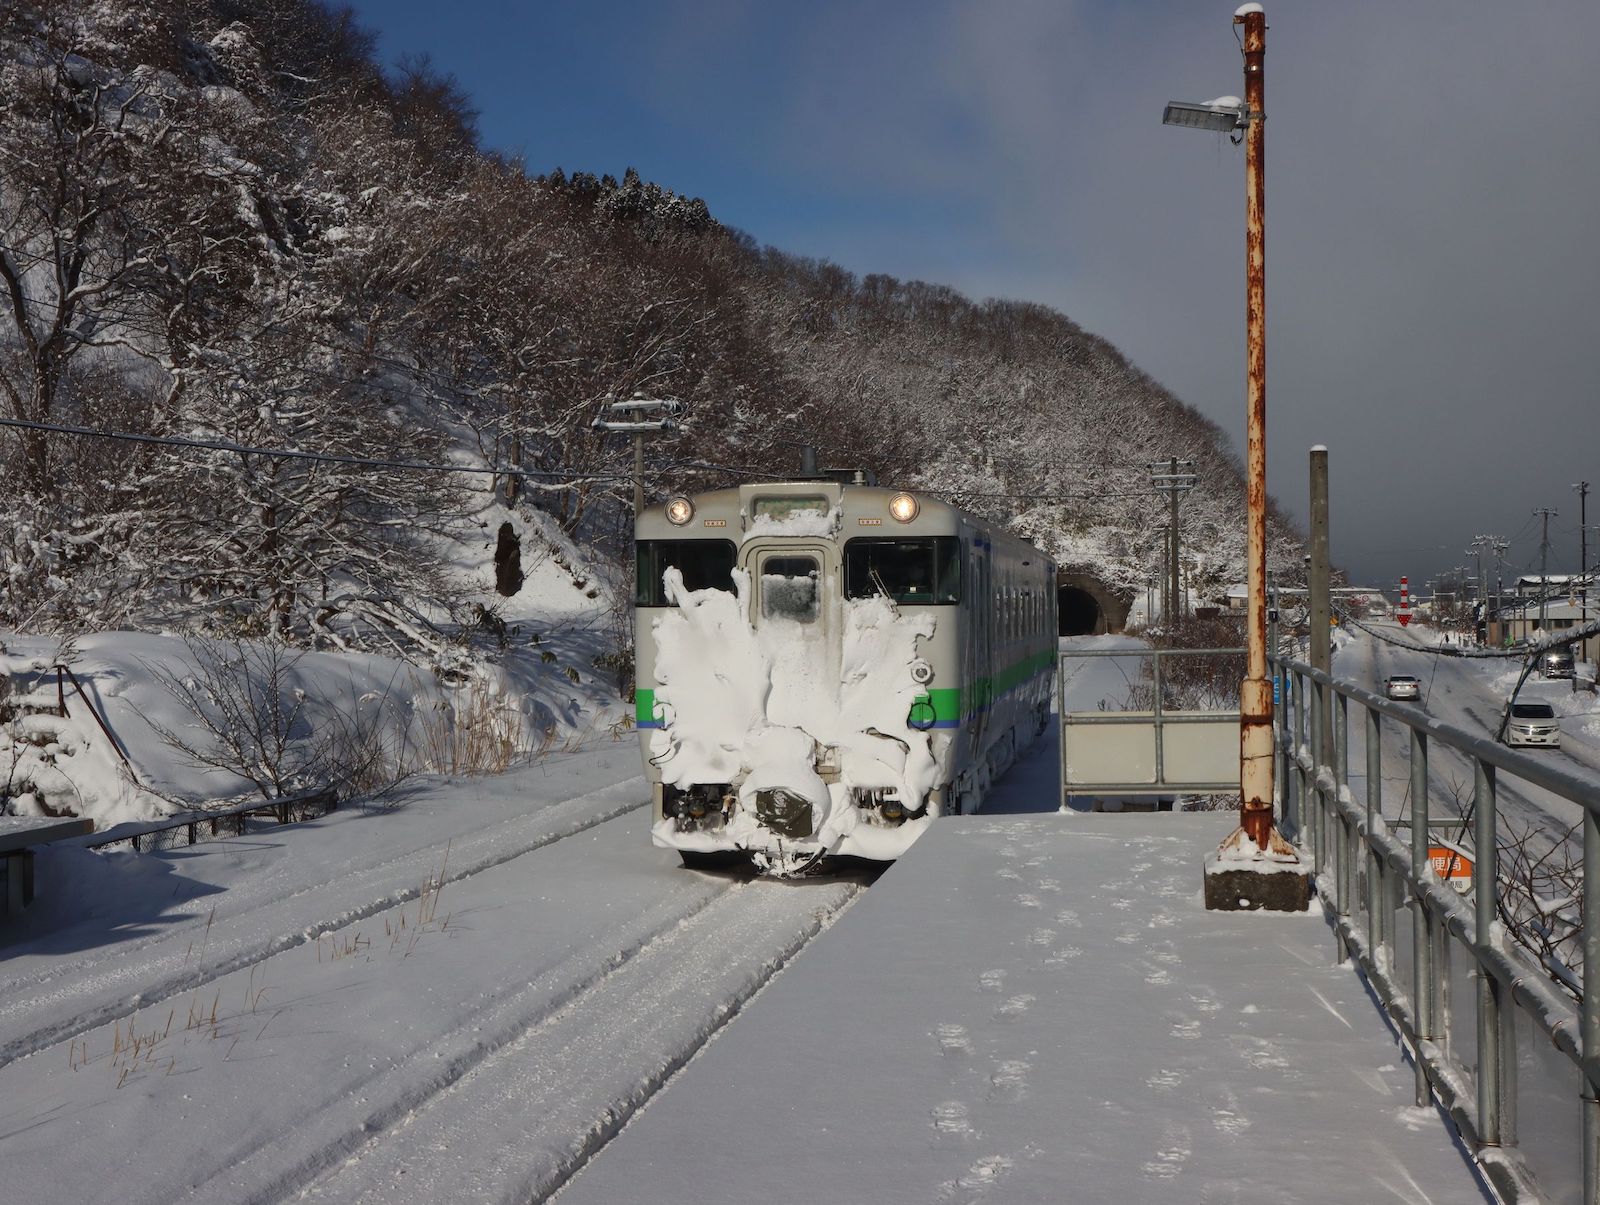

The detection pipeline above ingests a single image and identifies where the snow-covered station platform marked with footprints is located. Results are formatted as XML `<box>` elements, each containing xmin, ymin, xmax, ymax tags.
<box><xmin>560</xmin><ymin>813</ymin><xmax>1488</xmax><ymax>1205</ymax></box>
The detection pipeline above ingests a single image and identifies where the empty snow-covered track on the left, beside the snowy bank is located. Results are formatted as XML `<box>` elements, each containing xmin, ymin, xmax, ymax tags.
<box><xmin>0</xmin><ymin>759</ymin><xmax>648</xmax><ymax>1067</ymax></box>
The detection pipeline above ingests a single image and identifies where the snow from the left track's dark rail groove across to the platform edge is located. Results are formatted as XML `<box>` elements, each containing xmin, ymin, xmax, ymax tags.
<box><xmin>0</xmin><ymin>779</ymin><xmax>861</xmax><ymax>1202</ymax></box>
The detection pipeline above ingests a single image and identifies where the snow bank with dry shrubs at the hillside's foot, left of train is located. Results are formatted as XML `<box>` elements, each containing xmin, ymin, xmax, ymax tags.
<box><xmin>0</xmin><ymin>620</ymin><xmax>626</xmax><ymax>829</ymax></box>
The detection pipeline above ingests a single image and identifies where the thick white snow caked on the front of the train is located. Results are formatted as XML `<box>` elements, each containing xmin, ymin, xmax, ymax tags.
<box><xmin>650</xmin><ymin>569</ymin><xmax>947</xmax><ymax>858</ymax></box>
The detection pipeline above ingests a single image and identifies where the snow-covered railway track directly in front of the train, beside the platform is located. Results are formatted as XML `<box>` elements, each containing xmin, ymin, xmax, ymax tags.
<box><xmin>211</xmin><ymin>880</ymin><xmax>861</xmax><ymax>1205</ymax></box>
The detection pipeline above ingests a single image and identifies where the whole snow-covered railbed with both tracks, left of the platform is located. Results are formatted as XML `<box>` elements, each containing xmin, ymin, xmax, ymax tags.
<box><xmin>0</xmin><ymin>747</ymin><xmax>861</xmax><ymax>1202</ymax></box>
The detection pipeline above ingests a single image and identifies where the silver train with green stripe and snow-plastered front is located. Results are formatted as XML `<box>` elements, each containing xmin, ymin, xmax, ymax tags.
<box><xmin>635</xmin><ymin>474</ymin><xmax>1056</xmax><ymax>872</ymax></box>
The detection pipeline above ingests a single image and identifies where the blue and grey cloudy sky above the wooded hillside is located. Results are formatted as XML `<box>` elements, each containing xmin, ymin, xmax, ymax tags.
<box><xmin>347</xmin><ymin>0</ymin><xmax>1600</xmax><ymax>581</ymax></box>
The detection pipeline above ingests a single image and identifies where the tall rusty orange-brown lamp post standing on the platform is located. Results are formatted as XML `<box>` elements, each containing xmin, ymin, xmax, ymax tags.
<box><xmin>1234</xmin><ymin>8</ymin><xmax>1288</xmax><ymax>850</ymax></box>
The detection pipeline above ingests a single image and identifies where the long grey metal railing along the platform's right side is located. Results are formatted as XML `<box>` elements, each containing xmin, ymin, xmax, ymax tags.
<box><xmin>1270</xmin><ymin>656</ymin><xmax>1600</xmax><ymax>1205</ymax></box>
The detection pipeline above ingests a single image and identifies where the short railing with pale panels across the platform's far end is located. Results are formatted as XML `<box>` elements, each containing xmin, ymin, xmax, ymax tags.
<box><xmin>1056</xmin><ymin>647</ymin><xmax>1245</xmax><ymax>803</ymax></box>
